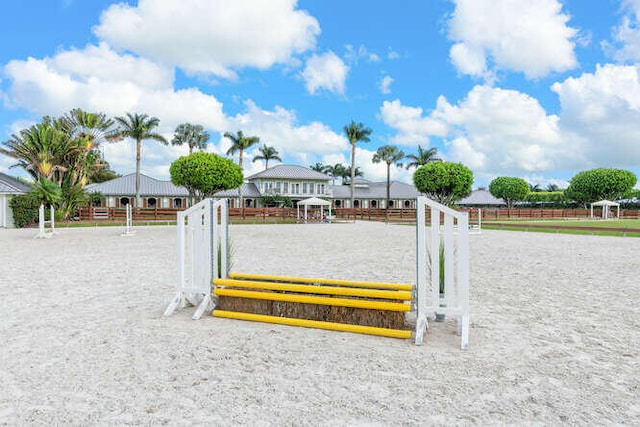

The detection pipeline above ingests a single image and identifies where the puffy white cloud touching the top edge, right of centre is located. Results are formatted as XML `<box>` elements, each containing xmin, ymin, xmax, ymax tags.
<box><xmin>448</xmin><ymin>0</ymin><xmax>577</xmax><ymax>78</ymax></box>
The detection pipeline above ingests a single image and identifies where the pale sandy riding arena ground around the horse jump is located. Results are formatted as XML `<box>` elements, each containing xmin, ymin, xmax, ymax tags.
<box><xmin>0</xmin><ymin>223</ymin><xmax>640</xmax><ymax>425</ymax></box>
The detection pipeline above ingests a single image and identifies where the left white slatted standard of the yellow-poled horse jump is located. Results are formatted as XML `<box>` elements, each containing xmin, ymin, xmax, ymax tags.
<box><xmin>164</xmin><ymin>199</ymin><xmax>229</xmax><ymax>320</ymax></box>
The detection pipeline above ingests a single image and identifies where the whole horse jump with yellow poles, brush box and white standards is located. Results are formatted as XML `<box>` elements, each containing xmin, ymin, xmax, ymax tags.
<box><xmin>165</xmin><ymin>196</ymin><xmax>469</xmax><ymax>349</ymax></box>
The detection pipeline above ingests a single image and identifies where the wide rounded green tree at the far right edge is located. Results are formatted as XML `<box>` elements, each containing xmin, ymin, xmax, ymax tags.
<box><xmin>565</xmin><ymin>168</ymin><xmax>637</xmax><ymax>206</ymax></box>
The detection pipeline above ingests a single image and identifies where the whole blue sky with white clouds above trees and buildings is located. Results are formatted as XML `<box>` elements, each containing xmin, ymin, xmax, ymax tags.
<box><xmin>0</xmin><ymin>0</ymin><xmax>640</xmax><ymax>187</ymax></box>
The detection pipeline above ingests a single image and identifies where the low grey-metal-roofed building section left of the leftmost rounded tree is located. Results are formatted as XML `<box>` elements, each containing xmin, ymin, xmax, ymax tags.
<box><xmin>86</xmin><ymin>173</ymin><xmax>189</xmax><ymax>208</ymax></box>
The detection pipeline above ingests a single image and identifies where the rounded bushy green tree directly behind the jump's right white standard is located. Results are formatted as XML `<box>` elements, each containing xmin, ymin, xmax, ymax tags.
<box><xmin>413</xmin><ymin>162</ymin><xmax>473</xmax><ymax>206</ymax></box>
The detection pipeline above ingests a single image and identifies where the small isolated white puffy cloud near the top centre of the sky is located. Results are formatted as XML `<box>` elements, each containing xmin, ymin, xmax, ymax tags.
<box><xmin>301</xmin><ymin>51</ymin><xmax>349</xmax><ymax>95</ymax></box>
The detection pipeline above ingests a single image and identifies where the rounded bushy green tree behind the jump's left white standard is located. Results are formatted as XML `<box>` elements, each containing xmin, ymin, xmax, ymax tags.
<box><xmin>169</xmin><ymin>151</ymin><xmax>244</xmax><ymax>200</ymax></box>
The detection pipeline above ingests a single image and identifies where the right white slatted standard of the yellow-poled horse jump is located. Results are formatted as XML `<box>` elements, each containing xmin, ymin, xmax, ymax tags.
<box><xmin>416</xmin><ymin>196</ymin><xmax>469</xmax><ymax>349</ymax></box>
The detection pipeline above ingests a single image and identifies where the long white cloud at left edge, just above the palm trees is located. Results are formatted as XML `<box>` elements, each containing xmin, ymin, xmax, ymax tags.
<box><xmin>4</xmin><ymin>45</ymin><xmax>226</xmax><ymax>132</ymax></box>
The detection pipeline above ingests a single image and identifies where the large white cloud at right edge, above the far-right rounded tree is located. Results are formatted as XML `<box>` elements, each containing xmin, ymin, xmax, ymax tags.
<box><xmin>552</xmin><ymin>64</ymin><xmax>640</xmax><ymax>167</ymax></box>
